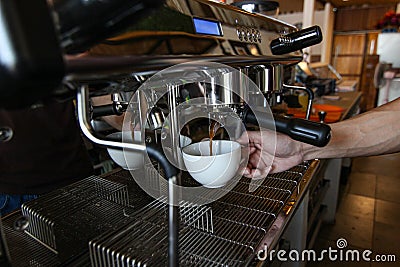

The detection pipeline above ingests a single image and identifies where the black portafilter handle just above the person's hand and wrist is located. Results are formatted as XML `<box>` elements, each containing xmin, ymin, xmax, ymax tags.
<box><xmin>243</xmin><ymin>108</ymin><xmax>331</xmax><ymax>147</ymax></box>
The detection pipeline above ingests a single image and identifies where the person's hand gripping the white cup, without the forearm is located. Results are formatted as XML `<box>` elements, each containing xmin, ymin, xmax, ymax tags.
<box><xmin>237</xmin><ymin>130</ymin><xmax>304</xmax><ymax>179</ymax></box>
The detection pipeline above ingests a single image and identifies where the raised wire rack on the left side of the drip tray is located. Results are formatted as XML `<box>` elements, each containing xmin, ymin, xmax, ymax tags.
<box><xmin>22</xmin><ymin>176</ymin><xmax>129</xmax><ymax>258</ymax></box>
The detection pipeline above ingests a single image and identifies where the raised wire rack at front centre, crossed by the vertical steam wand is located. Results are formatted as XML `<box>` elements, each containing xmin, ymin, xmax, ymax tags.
<box><xmin>89</xmin><ymin>199</ymin><xmax>213</xmax><ymax>267</ymax></box>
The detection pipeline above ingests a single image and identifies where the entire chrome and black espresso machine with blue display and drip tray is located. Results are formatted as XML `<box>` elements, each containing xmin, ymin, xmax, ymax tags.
<box><xmin>0</xmin><ymin>0</ymin><xmax>330</xmax><ymax>266</ymax></box>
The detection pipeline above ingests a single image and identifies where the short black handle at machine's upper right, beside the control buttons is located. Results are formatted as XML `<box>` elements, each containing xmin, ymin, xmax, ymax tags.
<box><xmin>270</xmin><ymin>25</ymin><xmax>322</xmax><ymax>55</ymax></box>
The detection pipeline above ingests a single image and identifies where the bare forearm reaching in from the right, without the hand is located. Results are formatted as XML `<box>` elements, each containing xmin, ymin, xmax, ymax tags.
<box><xmin>303</xmin><ymin>99</ymin><xmax>400</xmax><ymax>159</ymax></box>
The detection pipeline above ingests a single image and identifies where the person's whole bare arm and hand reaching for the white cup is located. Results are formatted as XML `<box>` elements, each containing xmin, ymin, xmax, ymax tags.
<box><xmin>238</xmin><ymin>98</ymin><xmax>400</xmax><ymax>178</ymax></box>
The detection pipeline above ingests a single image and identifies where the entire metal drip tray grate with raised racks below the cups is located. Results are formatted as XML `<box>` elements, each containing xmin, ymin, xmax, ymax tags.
<box><xmin>4</xmin><ymin>163</ymin><xmax>308</xmax><ymax>267</ymax></box>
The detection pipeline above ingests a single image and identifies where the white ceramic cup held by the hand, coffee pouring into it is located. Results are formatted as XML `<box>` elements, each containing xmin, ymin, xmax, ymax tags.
<box><xmin>182</xmin><ymin>140</ymin><xmax>241</xmax><ymax>188</ymax></box>
